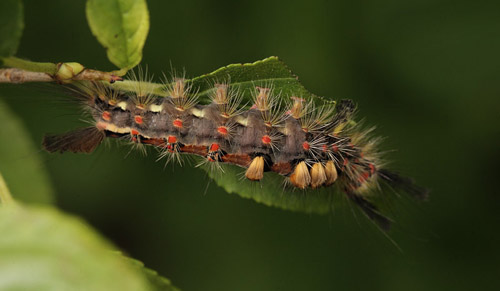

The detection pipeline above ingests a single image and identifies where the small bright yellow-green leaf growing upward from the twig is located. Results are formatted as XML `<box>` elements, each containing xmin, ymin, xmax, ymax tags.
<box><xmin>86</xmin><ymin>0</ymin><xmax>149</xmax><ymax>69</ymax></box>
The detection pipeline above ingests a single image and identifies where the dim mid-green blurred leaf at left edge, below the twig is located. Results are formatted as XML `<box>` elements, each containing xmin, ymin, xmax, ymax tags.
<box><xmin>0</xmin><ymin>100</ymin><xmax>54</xmax><ymax>203</ymax></box>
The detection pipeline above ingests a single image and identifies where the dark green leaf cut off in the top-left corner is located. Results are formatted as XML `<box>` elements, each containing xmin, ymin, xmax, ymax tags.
<box><xmin>0</xmin><ymin>0</ymin><xmax>24</xmax><ymax>57</ymax></box>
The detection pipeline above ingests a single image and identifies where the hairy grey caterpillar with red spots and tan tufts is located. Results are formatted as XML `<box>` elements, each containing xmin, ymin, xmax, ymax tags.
<box><xmin>43</xmin><ymin>60</ymin><xmax>428</xmax><ymax>230</ymax></box>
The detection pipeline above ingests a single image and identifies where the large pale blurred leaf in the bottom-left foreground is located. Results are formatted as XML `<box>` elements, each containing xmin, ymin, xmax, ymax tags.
<box><xmin>0</xmin><ymin>205</ymin><xmax>151</xmax><ymax>291</ymax></box>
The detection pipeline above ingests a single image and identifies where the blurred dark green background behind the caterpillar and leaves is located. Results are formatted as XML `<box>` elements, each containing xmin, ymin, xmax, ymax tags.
<box><xmin>0</xmin><ymin>0</ymin><xmax>500</xmax><ymax>290</ymax></box>
